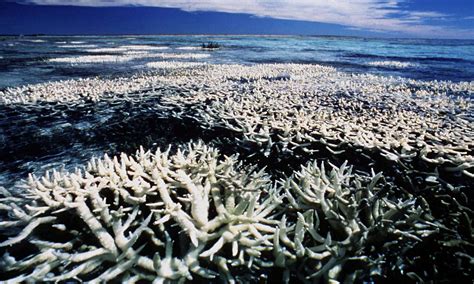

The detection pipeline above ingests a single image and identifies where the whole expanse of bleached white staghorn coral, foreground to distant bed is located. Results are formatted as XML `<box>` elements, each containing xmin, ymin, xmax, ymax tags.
<box><xmin>0</xmin><ymin>62</ymin><xmax>474</xmax><ymax>283</ymax></box>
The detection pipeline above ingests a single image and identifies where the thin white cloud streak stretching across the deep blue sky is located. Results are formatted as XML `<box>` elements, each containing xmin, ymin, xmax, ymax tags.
<box><xmin>12</xmin><ymin>0</ymin><xmax>474</xmax><ymax>37</ymax></box>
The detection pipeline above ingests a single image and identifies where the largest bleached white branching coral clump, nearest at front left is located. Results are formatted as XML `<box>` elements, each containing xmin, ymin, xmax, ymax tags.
<box><xmin>0</xmin><ymin>143</ymin><xmax>281</xmax><ymax>281</ymax></box>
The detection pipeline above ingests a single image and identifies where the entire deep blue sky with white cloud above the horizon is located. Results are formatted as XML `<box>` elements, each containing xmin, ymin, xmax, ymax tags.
<box><xmin>0</xmin><ymin>0</ymin><xmax>474</xmax><ymax>39</ymax></box>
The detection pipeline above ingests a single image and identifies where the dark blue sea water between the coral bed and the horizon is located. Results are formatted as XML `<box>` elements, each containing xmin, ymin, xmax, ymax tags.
<box><xmin>0</xmin><ymin>36</ymin><xmax>474</xmax><ymax>88</ymax></box>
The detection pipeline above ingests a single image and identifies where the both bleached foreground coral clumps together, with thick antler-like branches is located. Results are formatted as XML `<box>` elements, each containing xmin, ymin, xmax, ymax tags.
<box><xmin>0</xmin><ymin>142</ymin><xmax>444</xmax><ymax>282</ymax></box>
